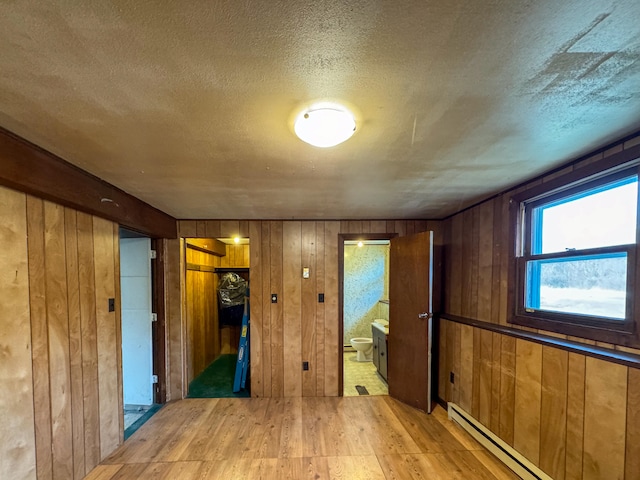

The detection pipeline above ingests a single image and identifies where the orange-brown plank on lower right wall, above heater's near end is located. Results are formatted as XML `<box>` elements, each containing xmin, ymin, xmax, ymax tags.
<box><xmin>540</xmin><ymin>346</ymin><xmax>569</xmax><ymax>480</ymax></box>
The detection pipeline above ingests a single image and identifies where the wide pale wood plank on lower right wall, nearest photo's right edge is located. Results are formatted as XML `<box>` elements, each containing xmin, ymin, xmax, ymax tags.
<box><xmin>583</xmin><ymin>357</ymin><xmax>628</xmax><ymax>479</ymax></box>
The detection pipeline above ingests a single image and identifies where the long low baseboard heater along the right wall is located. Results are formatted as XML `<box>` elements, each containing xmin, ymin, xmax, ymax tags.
<box><xmin>448</xmin><ymin>402</ymin><xmax>553</xmax><ymax>480</ymax></box>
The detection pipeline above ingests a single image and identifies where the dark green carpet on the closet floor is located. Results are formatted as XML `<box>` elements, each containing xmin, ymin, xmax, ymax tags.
<box><xmin>188</xmin><ymin>354</ymin><xmax>250</xmax><ymax>398</ymax></box>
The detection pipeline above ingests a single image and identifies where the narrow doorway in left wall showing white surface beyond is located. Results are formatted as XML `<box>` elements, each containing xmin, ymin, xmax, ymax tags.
<box><xmin>119</xmin><ymin>228</ymin><xmax>164</xmax><ymax>439</ymax></box>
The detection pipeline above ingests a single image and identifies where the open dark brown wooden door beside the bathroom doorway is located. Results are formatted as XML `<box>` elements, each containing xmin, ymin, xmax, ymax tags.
<box><xmin>387</xmin><ymin>232</ymin><xmax>433</xmax><ymax>413</ymax></box>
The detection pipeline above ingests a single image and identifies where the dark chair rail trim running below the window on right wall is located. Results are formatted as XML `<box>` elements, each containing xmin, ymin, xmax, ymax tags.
<box><xmin>440</xmin><ymin>313</ymin><xmax>640</xmax><ymax>369</ymax></box>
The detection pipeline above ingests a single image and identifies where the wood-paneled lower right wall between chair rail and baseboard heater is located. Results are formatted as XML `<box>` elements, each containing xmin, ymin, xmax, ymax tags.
<box><xmin>439</xmin><ymin>320</ymin><xmax>640</xmax><ymax>480</ymax></box>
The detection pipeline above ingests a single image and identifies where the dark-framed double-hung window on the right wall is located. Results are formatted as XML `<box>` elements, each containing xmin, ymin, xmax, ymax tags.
<box><xmin>512</xmin><ymin>167</ymin><xmax>638</xmax><ymax>343</ymax></box>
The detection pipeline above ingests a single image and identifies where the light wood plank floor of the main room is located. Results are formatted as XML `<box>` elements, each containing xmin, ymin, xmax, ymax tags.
<box><xmin>86</xmin><ymin>396</ymin><xmax>518</xmax><ymax>480</ymax></box>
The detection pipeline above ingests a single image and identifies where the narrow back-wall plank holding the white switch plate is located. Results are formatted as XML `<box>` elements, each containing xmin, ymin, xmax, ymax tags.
<box><xmin>299</xmin><ymin>222</ymin><xmax>318</xmax><ymax>397</ymax></box>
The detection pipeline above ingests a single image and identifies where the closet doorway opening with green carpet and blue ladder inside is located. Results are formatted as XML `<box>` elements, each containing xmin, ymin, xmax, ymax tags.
<box><xmin>184</xmin><ymin>237</ymin><xmax>250</xmax><ymax>398</ymax></box>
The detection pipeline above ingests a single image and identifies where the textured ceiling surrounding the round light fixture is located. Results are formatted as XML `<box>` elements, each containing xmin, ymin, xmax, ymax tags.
<box><xmin>0</xmin><ymin>0</ymin><xmax>640</xmax><ymax>219</ymax></box>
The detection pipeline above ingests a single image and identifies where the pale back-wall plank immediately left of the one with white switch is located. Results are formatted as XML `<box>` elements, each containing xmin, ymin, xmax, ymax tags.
<box><xmin>282</xmin><ymin>222</ymin><xmax>302</xmax><ymax>397</ymax></box>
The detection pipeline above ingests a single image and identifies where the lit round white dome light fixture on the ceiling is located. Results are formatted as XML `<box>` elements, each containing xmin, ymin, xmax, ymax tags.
<box><xmin>294</xmin><ymin>103</ymin><xmax>356</xmax><ymax>148</ymax></box>
